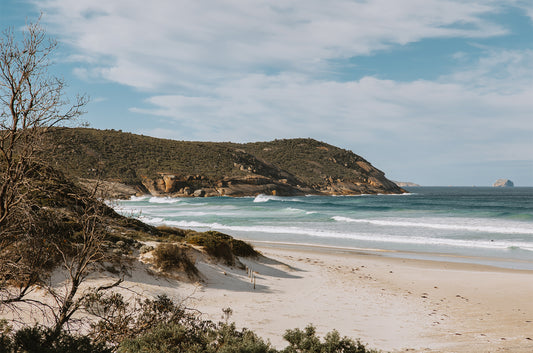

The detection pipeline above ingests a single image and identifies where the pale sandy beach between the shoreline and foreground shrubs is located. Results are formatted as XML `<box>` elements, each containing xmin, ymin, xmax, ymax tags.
<box><xmin>128</xmin><ymin>246</ymin><xmax>533</xmax><ymax>352</ymax></box>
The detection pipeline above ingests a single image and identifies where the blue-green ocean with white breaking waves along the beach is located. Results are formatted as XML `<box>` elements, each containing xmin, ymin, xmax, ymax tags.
<box><xmin>114</xmin><ymin>187</ymin><xmax>533</xmax><ymax>270</ymax></box>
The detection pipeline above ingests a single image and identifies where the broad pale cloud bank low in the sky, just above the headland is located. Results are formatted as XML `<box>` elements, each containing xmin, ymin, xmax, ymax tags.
<box><xmin>131</xmin><ymin>53</ymin><xmax>533</xmax><ymax>159</ymax></box>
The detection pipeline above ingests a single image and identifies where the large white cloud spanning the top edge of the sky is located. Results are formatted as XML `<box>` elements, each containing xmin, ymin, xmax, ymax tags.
<box><xmin>35</xmin><ymin>0</ymin><xmax>506</xmax><ymax>90</ymax></box>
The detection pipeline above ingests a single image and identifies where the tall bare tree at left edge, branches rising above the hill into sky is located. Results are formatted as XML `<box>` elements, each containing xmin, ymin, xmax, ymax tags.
<box><xmin>0</xmin><ymin>19</ymin><xmax>87</xmax><ymax>304</ymax></box>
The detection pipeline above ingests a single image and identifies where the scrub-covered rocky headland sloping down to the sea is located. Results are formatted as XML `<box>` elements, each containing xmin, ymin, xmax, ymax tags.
<box><xmin>45</xmin><ymin>128</ymin><xmax>405</xmax><ymax>197</ymax></box>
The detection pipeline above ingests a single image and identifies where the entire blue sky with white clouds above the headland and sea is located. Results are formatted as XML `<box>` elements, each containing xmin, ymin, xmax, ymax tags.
<box><xmin>0</xmin><ymin>0</ymin><xmax>533</xmax><ymax>186</ymax></box>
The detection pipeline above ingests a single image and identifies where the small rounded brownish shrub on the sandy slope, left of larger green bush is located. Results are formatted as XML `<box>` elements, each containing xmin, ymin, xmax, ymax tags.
<box><xmin>154</xmin><ymin>243</ymin><xmax>199</xmax><ymax>278</ymax></box>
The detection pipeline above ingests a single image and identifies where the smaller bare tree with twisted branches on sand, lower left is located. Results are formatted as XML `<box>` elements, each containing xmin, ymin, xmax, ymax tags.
<box><xmin>0</xmin><ymin>168</ymin><xmax>128</xmax><ymax>340</ymax></box>
